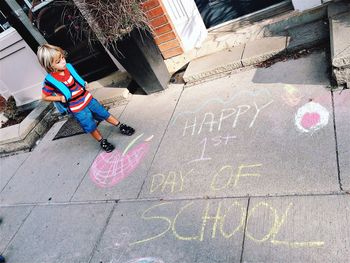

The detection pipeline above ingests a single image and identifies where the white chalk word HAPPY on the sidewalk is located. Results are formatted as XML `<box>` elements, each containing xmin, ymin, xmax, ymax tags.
<box><xmin>182</xmin><ymin>100</ymin><xmax>273</xmax><ymax>136</ymax></box>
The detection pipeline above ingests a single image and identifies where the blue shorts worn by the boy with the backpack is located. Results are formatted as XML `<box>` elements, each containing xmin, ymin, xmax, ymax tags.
<box><xmin>73</xmin><ymin>98</ymin><xmax>111</xmax><ymax>133</ymax></box>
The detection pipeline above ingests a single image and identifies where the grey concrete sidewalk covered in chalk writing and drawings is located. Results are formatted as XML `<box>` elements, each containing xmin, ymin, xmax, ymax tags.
<box><xmin>0</xmin><ymin>52</ymin><xmax>350</xmax><ymax>263</ymax></box>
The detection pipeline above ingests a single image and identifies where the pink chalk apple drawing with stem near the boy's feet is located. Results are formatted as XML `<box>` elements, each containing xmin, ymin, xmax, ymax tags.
<box><xmin>89</xmin><ymin>134</ymin><xmax>153</xmax><ymax>188</ymax></box>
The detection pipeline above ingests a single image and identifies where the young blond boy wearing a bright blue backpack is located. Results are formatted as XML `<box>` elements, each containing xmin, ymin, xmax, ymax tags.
<box><xmin>37</xmin><ymin>44</ymin><xmax>135</xmax><ymax>152</ymax></box>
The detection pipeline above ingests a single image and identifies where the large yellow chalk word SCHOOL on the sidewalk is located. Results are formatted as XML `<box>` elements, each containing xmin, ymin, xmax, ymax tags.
<box><xmin>129</xmin><ymin>201</ymin><xmax>324</xmax><ymax>248</ymax></box>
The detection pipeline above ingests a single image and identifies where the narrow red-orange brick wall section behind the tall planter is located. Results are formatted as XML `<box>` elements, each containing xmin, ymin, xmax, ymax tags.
<box><xmin>141</xmin><ymin>0</ymin><xmax>183</xmax><ymax>59</ymax></box>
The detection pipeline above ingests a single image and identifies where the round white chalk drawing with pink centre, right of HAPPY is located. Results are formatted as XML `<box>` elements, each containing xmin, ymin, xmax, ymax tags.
<box><xmin>295</xmin><ymin>101</ymin><xmax>329</xmax><ymax>132</ymax></box>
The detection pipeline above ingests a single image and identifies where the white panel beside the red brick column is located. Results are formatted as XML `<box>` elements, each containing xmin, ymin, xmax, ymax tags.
<box><xmin>163</xmin><ymin>0</ymin><xmax>208</xmax><ymax>51</ymax></box>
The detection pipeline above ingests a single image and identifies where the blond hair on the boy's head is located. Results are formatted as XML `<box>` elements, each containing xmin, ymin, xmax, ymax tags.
<box><xmin>36</xmin><ymin>44</ymin><xmax>66</xmax><ymax>73</ymax></box>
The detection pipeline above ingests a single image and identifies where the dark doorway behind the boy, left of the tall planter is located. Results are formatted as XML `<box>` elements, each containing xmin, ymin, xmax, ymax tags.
<box><xmin>16</xmin><ymin>0</ymin><xmax>118</xmax><ymax>82</ymax></box>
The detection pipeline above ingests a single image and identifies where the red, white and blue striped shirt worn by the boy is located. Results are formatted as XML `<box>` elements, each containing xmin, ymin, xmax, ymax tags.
<box><xmin>42</xmin><ymin>69</ymin><xmax>92</xmax><ymax>112</ymax></box>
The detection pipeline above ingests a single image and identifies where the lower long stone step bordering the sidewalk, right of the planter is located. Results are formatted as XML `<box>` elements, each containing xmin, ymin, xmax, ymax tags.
<box><xmin>183</xmin><ymin>9</ymin><xmax>329</xmax><ymax>85</ymax></box>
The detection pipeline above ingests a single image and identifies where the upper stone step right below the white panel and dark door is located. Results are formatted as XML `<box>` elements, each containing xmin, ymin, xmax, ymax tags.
<box><xmin>165</xmin><ymin>3</ymin><xmax>328</xmax><ymax>73</ymax></box>
